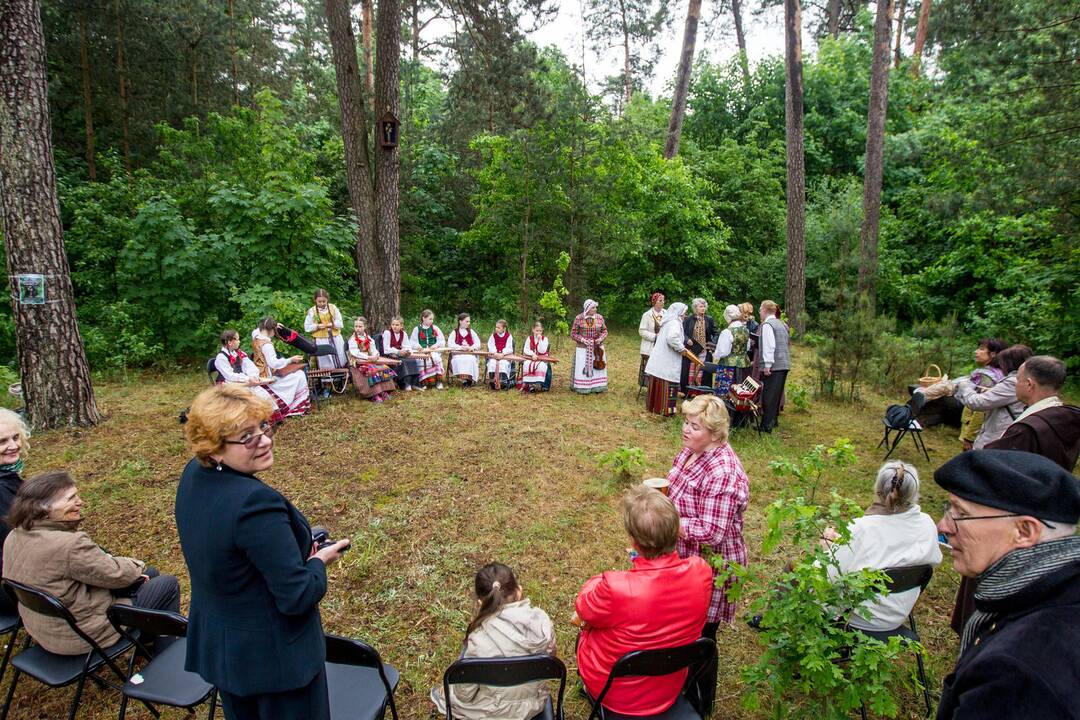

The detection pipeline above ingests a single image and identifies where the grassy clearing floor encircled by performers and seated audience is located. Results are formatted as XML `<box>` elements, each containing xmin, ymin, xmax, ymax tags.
<box><xmin>5</xmin><ymin>331</ymin><xmax>989</xmax><ymax>720</ymax></box>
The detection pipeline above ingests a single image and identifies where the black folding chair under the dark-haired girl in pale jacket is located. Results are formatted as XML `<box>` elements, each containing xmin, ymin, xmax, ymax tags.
<box><xmin>443</xmin><ymin>655</ymin><xmax>566</xmax><ymax>720</ymax></box>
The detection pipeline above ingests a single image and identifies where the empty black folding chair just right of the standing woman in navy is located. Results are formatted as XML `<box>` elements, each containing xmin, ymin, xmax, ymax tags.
<box><xmin>326</xmin><ymin>633</ymin><xmax>401</xmax><ymax>720</ymax></box>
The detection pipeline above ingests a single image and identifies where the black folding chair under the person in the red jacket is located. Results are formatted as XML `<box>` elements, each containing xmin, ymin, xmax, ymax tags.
<box><xmin>589</xmin><ymin>638</ymin><xmax>716</xmax><ymax>720</ymax></box>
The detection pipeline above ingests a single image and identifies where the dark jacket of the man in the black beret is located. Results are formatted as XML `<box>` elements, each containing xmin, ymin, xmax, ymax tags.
<box><xmin>937</xmin><ymin>562</ymin><xmax>1080</xmax><ymax>720</ymax></box>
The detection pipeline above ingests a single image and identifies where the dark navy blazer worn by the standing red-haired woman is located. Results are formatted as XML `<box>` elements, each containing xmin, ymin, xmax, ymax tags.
<box><xmin>176</xmin><ymin>460</ymin><xmax>326</xmax><ymax>695</ymax></box>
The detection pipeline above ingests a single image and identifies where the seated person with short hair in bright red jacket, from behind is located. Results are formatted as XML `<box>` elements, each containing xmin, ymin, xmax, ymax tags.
<box><xmin>575</xmin><ymin>486</ymin><xmax>713</xmax><ymax>715</ymax></box>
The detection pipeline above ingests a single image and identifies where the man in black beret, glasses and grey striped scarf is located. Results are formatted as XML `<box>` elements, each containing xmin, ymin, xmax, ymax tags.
<box><xmin>934</xmin><ymin>450</ymin><xmax>1080</xmax><ymax>720</ymax></box>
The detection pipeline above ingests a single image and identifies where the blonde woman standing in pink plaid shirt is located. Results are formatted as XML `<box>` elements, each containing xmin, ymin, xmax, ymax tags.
<box><xmin>667</xmin><ymin>395</ymin><xmax>750</xmax><ymax>711</ymax></box>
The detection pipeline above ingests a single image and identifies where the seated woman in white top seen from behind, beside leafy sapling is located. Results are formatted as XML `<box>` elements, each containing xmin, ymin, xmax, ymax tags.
<box><xmin>828</xmin><ymin>460</ymin><xmax>942</xmax><ymax>631</ymax></box>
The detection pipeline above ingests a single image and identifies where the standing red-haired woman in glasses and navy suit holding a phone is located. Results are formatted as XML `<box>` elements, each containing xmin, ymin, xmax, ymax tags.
<box><xmin>176</xmin><ymin>383</ymin><xmax>349</xmax><ymax>720</ymax></box>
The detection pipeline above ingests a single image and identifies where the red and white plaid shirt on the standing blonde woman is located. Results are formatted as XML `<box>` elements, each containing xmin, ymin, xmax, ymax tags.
<box><xmin>667</xmin><ymin>444</ymin><xmax>750</xmax><ymax>623</ymax></box>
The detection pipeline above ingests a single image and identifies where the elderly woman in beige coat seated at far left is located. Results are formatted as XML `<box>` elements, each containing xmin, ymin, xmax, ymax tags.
<box><xmin>3</xmin><ymin>471</ymin><xmax>180</xmax><ymax>655</ymax></box>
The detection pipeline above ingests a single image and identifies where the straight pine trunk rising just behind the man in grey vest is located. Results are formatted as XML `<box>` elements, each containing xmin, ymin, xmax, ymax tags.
<box><xmin>784</xmin><ymin>0</ymin><xmax>807</xmax><ymax>336</ymax></box>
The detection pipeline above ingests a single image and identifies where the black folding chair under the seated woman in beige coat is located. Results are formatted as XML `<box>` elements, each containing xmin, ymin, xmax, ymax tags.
<box><xmin>0</xmin><ymin>580</ymin><xmax>159</xmax><ymax>720</ymax></box>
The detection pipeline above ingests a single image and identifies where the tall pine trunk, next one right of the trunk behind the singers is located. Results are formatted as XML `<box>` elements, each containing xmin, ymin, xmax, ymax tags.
<box><xmin>859</xmin><ymin>0</ymin><xmax>892</xmax><ymax>309</ymax></box>
